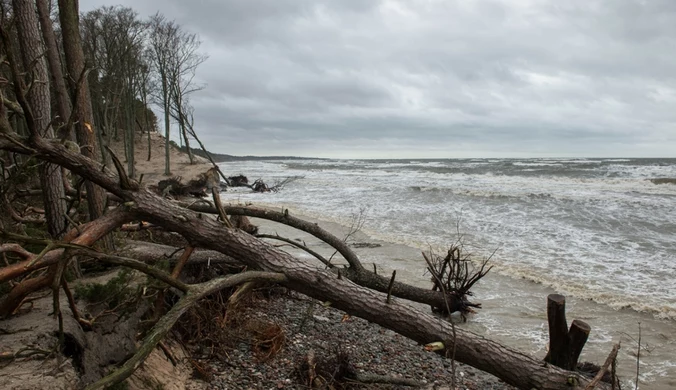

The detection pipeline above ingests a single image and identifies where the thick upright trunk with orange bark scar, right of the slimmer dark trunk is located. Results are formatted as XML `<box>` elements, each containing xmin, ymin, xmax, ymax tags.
<box><xmin>59</xmin><ymin>0</ymin><xmax>110</xmax><ymax>229</ymax></box>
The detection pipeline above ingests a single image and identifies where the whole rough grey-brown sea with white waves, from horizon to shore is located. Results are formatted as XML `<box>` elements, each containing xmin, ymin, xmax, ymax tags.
<box><xmin>221</xmin><ymin>158</ymin><xmax>676</xmax><ymax>390</ymax></box>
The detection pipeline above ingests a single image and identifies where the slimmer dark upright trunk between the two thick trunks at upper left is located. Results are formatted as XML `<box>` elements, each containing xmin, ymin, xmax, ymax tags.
<box><xmin>36</xmin><ymin>0</ymin><xmax>75</xmax><ymax>140</ymax></box>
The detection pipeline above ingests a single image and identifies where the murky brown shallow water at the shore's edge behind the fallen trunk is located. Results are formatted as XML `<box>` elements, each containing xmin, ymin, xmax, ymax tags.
<box><xmin>222</xmin><ymin>198</ymin><xmax>676</xmax><ymax>390</ymax></box>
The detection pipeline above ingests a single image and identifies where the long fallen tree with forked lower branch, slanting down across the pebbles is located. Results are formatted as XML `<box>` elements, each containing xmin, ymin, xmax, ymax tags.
<box><xmin>0</xmin><ymin>129</ymin><xmax>610</xmax><ymax>390</ymax></box>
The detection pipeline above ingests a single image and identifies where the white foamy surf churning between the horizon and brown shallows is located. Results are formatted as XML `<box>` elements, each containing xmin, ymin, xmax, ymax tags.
<box><xmin>220</xmin><ymin>159</ymin><xmax>676</xmax><ymax>318</ymax></box>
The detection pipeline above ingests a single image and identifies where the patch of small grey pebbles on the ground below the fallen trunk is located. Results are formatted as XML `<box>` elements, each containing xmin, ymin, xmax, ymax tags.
<box><xmin>203</xmin><ymin>293</ymin><xmax>514</xmax><ymax>390</ymax></box>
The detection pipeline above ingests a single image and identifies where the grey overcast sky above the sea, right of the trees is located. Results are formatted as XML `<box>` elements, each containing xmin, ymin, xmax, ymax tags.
<box><xmin>80</xmin><ymin>0</ymin><xmax>676</xmax><ymax>158</ymax></box>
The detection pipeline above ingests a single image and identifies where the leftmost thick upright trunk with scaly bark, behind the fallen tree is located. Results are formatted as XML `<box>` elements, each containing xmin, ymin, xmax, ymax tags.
<box><xmin>13</xmin><ymin>0</ymin><xmax>66</xmax><ymax>238</ymax></box>
